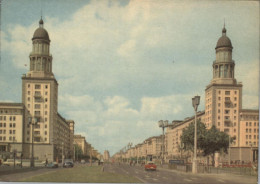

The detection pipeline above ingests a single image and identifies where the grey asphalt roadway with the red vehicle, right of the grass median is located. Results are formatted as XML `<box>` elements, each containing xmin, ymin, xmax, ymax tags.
<box><xmin>104</xmin><ymin>164</ymin><xmax>257</xmax><ymax>184</ymax></box>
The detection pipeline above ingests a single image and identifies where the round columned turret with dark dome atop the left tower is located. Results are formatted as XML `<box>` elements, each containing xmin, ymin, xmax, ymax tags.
<box><xmin>27</xmin><ymin>18</ymin><xmax>53</xmax><ymax>77</ymax></box>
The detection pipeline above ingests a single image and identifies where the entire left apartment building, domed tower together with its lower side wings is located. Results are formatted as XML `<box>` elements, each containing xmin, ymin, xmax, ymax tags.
<box><xmin>0</xmin><ymin>19</ymin><xmax>74</xmax><ymax>161</ymax></box>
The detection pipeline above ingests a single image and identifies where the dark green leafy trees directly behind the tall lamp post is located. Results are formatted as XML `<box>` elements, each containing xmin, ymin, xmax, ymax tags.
<box><xmin>181</xmin><ymin>121</ymin><xmax>233</xmax><ymax>165</ymax></box>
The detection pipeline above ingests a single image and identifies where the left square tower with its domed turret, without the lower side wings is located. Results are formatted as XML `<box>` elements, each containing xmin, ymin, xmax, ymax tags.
<box><xmin>22</xmin><ymin>19</ymin><xmax>58</xmax><ymax>160</ymax></box>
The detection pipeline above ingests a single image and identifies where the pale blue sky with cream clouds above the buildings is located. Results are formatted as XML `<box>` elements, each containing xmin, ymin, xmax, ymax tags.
<box><xmin>0</xmin><ymin>0</ymin><xmax>259</xmax><ymax>155</ymax></box>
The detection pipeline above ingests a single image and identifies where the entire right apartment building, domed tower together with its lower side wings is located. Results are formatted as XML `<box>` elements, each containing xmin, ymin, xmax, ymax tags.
<box><xmin>166</xmin><ymin>27</ymin><xmax>259</xmax><ymax>161</ymax></box>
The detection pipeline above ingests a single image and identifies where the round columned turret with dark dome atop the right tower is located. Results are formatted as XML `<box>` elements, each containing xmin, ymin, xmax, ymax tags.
<box><xmin>211</xmin><ymin>26</ymin><xmax>236</xmax><ymax>84</ymax></box>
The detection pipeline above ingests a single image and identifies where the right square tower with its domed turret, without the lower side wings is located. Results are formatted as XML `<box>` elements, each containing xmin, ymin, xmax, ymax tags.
<box><xmin>205</xmin><ymin>25</ymin><xmax>242</xmax><ymax>147</ymax></box>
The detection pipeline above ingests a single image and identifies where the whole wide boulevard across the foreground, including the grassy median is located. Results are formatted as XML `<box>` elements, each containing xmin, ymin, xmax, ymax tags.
<box><xmin>0</xmin><ymin>163</ymin><xmax>257</xmax><ymax>184</ymax></box>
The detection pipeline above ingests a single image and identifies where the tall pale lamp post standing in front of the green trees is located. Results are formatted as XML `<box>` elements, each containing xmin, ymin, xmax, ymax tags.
<box><xmin>192</xmin><ymin>96</ymin><xmax>200</xmax><ymax>173</ymax></box>
